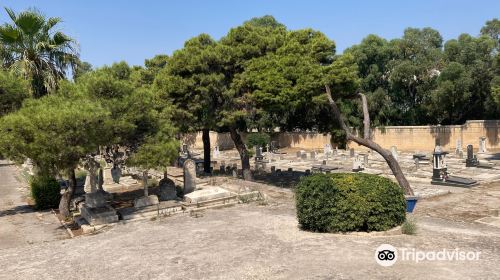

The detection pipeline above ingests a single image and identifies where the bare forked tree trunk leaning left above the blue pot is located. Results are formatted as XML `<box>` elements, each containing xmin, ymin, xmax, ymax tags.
<box><xmin>325</xmin><ymin>86</ymin><xmax>414</xmax><ymax>196</ymax></box>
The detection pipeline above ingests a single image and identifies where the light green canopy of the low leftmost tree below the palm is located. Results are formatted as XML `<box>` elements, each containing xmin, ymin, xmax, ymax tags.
<box><xmin>0</xmin><ymin>95</ymin><xmax>111</xmax><ymax>174</ymax></box>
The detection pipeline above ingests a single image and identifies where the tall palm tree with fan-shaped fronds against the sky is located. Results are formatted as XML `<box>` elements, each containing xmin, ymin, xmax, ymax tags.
<box><xmin>0</xmin><ymin>8</ymin><xmax>79</xmax><ymax>97</ymax></box>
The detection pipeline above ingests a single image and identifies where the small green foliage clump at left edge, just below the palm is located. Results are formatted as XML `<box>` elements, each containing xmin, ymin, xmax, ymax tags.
<box><xmin>0</xmin><ymin>69</ymin><xmax>30</xmax><ymax>117</ymax></box>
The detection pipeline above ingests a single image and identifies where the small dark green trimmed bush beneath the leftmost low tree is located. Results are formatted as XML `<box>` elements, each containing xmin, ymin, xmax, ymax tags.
<box><xmin>31</xmin><ymin>175</ymin><xmax>61</xmax><ymax>209</ymax></box>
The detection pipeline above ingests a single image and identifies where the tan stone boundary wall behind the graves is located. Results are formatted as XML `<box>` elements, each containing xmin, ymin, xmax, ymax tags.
<box><xmin>184</xmin><ymin>120</ymin><xmax>500</xmax><ymax>152</ymax></box>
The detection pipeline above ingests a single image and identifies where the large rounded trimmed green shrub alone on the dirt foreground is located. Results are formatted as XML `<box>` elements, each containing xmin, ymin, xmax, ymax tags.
<box><xmin>295</xmin><ymin>173</ymin><xmax>406</xmax><ymax>232</ymax></box>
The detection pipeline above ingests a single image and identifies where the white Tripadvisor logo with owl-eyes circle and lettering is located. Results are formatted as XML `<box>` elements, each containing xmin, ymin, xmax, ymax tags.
<box><xmin>375</xmin><ymin>244</ymin><xmax>481</xmax><ymax>266</ymax></box>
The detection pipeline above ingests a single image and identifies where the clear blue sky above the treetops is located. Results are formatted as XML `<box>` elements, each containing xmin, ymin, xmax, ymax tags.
<box><xmin>0</xmin><ymin>0</ymin><xmax>500</xmax><ymax>66</ymax></box>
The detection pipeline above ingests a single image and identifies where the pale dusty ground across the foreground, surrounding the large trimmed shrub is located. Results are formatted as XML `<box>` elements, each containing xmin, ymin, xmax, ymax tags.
<box><xmin>0</xmin><ymin>161</ymin><xmax>500</xmax><ymax>280</ymax></box>
